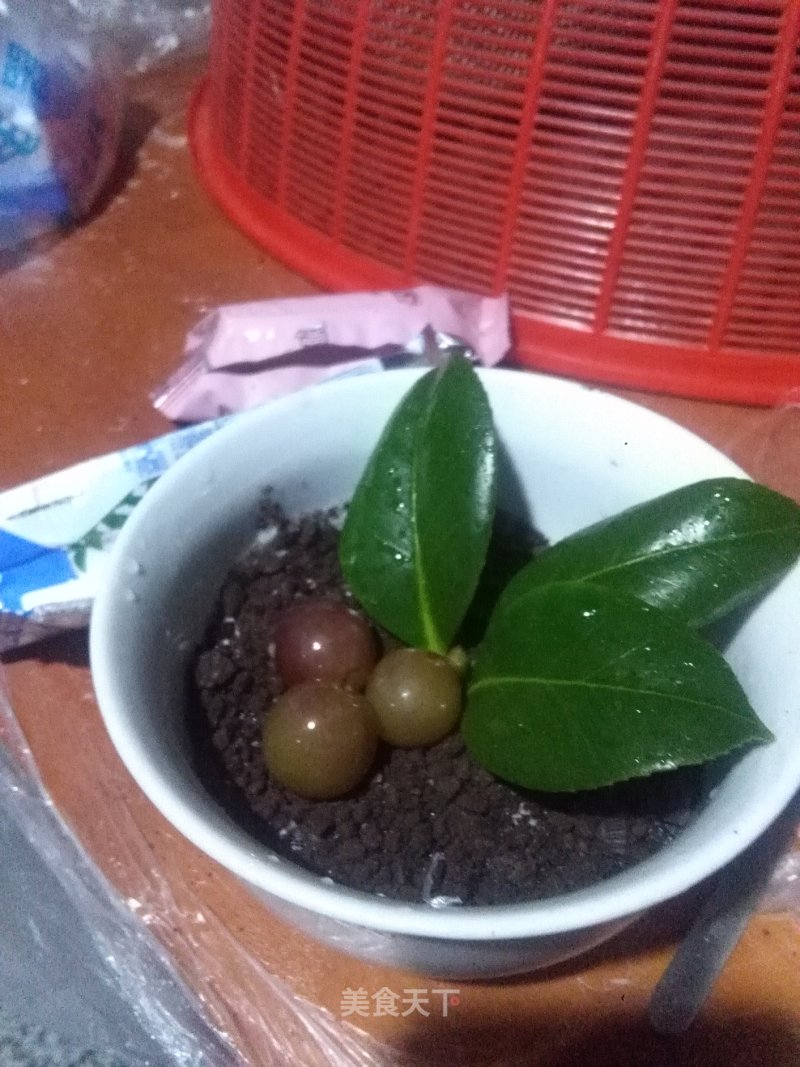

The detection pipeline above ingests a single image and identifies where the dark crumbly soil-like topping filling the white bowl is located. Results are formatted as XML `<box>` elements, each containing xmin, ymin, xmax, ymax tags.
<box><xmin>190</xmin><ymin>500</ymin><xmax>701</xmax><ymax>906</ymax></box>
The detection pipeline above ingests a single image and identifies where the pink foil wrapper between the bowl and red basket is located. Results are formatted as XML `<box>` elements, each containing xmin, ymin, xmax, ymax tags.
<box><xmin>153</xmin><ymin>285</ymin><xmax>511</xmax><ymax>421</ymax></box>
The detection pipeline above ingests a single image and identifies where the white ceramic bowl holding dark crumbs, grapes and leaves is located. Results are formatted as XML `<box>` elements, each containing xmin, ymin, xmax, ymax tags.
<box><xmin>91</xmin><ymin>370</ymin><xmax>800</xmax><ymax>978</ymax></box>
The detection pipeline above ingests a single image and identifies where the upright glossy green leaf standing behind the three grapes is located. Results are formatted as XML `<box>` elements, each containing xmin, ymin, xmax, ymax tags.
<box><xmin>339</xmin><ymin>356</ymin><xmax>496</xmax><ymax>652</ymax></box>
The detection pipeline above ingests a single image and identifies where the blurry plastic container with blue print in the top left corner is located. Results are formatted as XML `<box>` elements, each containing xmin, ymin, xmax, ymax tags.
<box><xmin>0</xmin><ymin>2</ymin><xmax>125</xmax><ymax>249</ymax></box>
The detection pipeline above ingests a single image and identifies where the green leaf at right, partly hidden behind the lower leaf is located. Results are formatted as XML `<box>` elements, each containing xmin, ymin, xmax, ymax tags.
<box><xmin>503</xmin><ymin>478</ymin><xmax>800</xmax><ymax>626</ymax></box>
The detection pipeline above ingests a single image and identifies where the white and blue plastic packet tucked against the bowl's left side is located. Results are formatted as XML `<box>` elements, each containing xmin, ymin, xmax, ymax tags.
<box><xmin>0</xmin><ymin>421</ymin><xmax>222</xmax><ymax>653</ymax></box>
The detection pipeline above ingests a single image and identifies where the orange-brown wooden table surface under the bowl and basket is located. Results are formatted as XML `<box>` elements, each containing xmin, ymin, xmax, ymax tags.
<box><xmin>0</xmin><ymin>58</ymin><xmax>800</xmax><ymax>1067</ymax></box>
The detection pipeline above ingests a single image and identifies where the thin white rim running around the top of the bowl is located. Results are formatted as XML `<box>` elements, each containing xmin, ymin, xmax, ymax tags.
<box><xmin>90</xmin><ymin>368</ymin><xmax>800</xmax><ymax>942</ymax></box>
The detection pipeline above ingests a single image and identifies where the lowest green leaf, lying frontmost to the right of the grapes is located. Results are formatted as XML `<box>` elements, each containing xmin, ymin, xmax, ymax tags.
<box><xmin>462</xmin><ymin>583</ymin><xmax>772</xmax><ymax>792</ymax></box>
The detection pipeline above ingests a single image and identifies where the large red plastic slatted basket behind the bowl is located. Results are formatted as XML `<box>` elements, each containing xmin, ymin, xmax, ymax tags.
<box><xmin>191</xmin><ymin>0</ymin><xmax>800</xmax><ymax>403</ymax></box>
